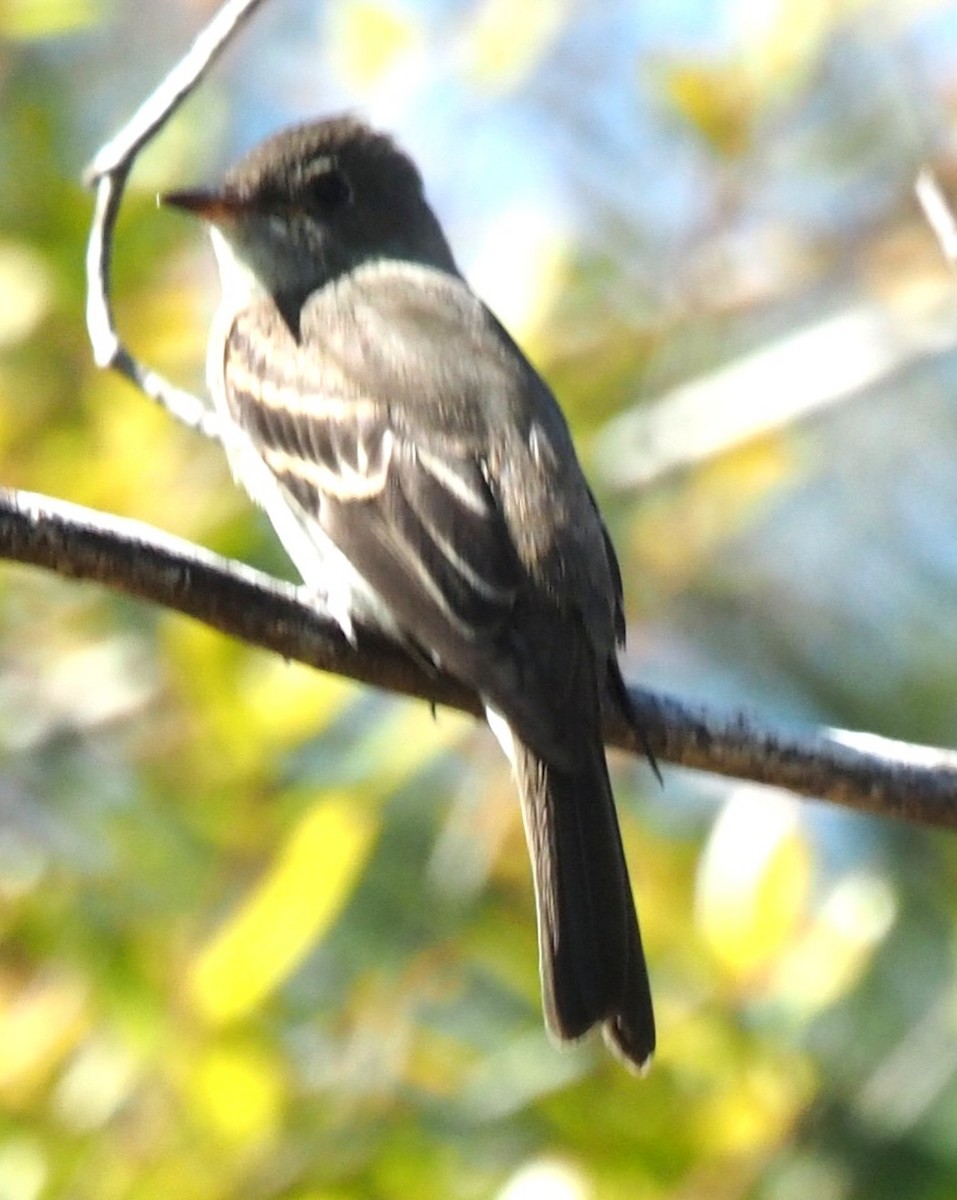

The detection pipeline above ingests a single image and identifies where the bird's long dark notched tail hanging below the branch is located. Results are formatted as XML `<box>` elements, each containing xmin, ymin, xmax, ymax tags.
<box><xmin>514</xmin><ymin>737</ymin><xmax>655</xmax><ymax>1069</ymax></box>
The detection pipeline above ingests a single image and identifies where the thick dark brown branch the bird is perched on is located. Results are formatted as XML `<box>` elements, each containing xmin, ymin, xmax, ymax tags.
<box><xmin>0</xmin><ymin>490</ymin><xmax>957</xmax><ymax>827</ymax></box>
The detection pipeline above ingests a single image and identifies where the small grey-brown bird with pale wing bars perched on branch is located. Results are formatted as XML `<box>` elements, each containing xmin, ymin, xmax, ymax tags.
<box><xmin>164</xmin><ymin>116</ymin><xmax>655</xmax><ymax>1067</ymax></box>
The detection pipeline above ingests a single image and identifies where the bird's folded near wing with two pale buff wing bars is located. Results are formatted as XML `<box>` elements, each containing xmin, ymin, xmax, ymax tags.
<box><xmin>224</xmin><ymin>282</ymin><xmax>522</xmax><ymax>644</ymax></box>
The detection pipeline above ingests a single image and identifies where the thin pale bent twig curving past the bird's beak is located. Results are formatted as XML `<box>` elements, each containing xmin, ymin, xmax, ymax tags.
<box><xmin>84</xmin><ymin>0</ymin><xmax>269</xmax><ymax>439</ymax></box>
